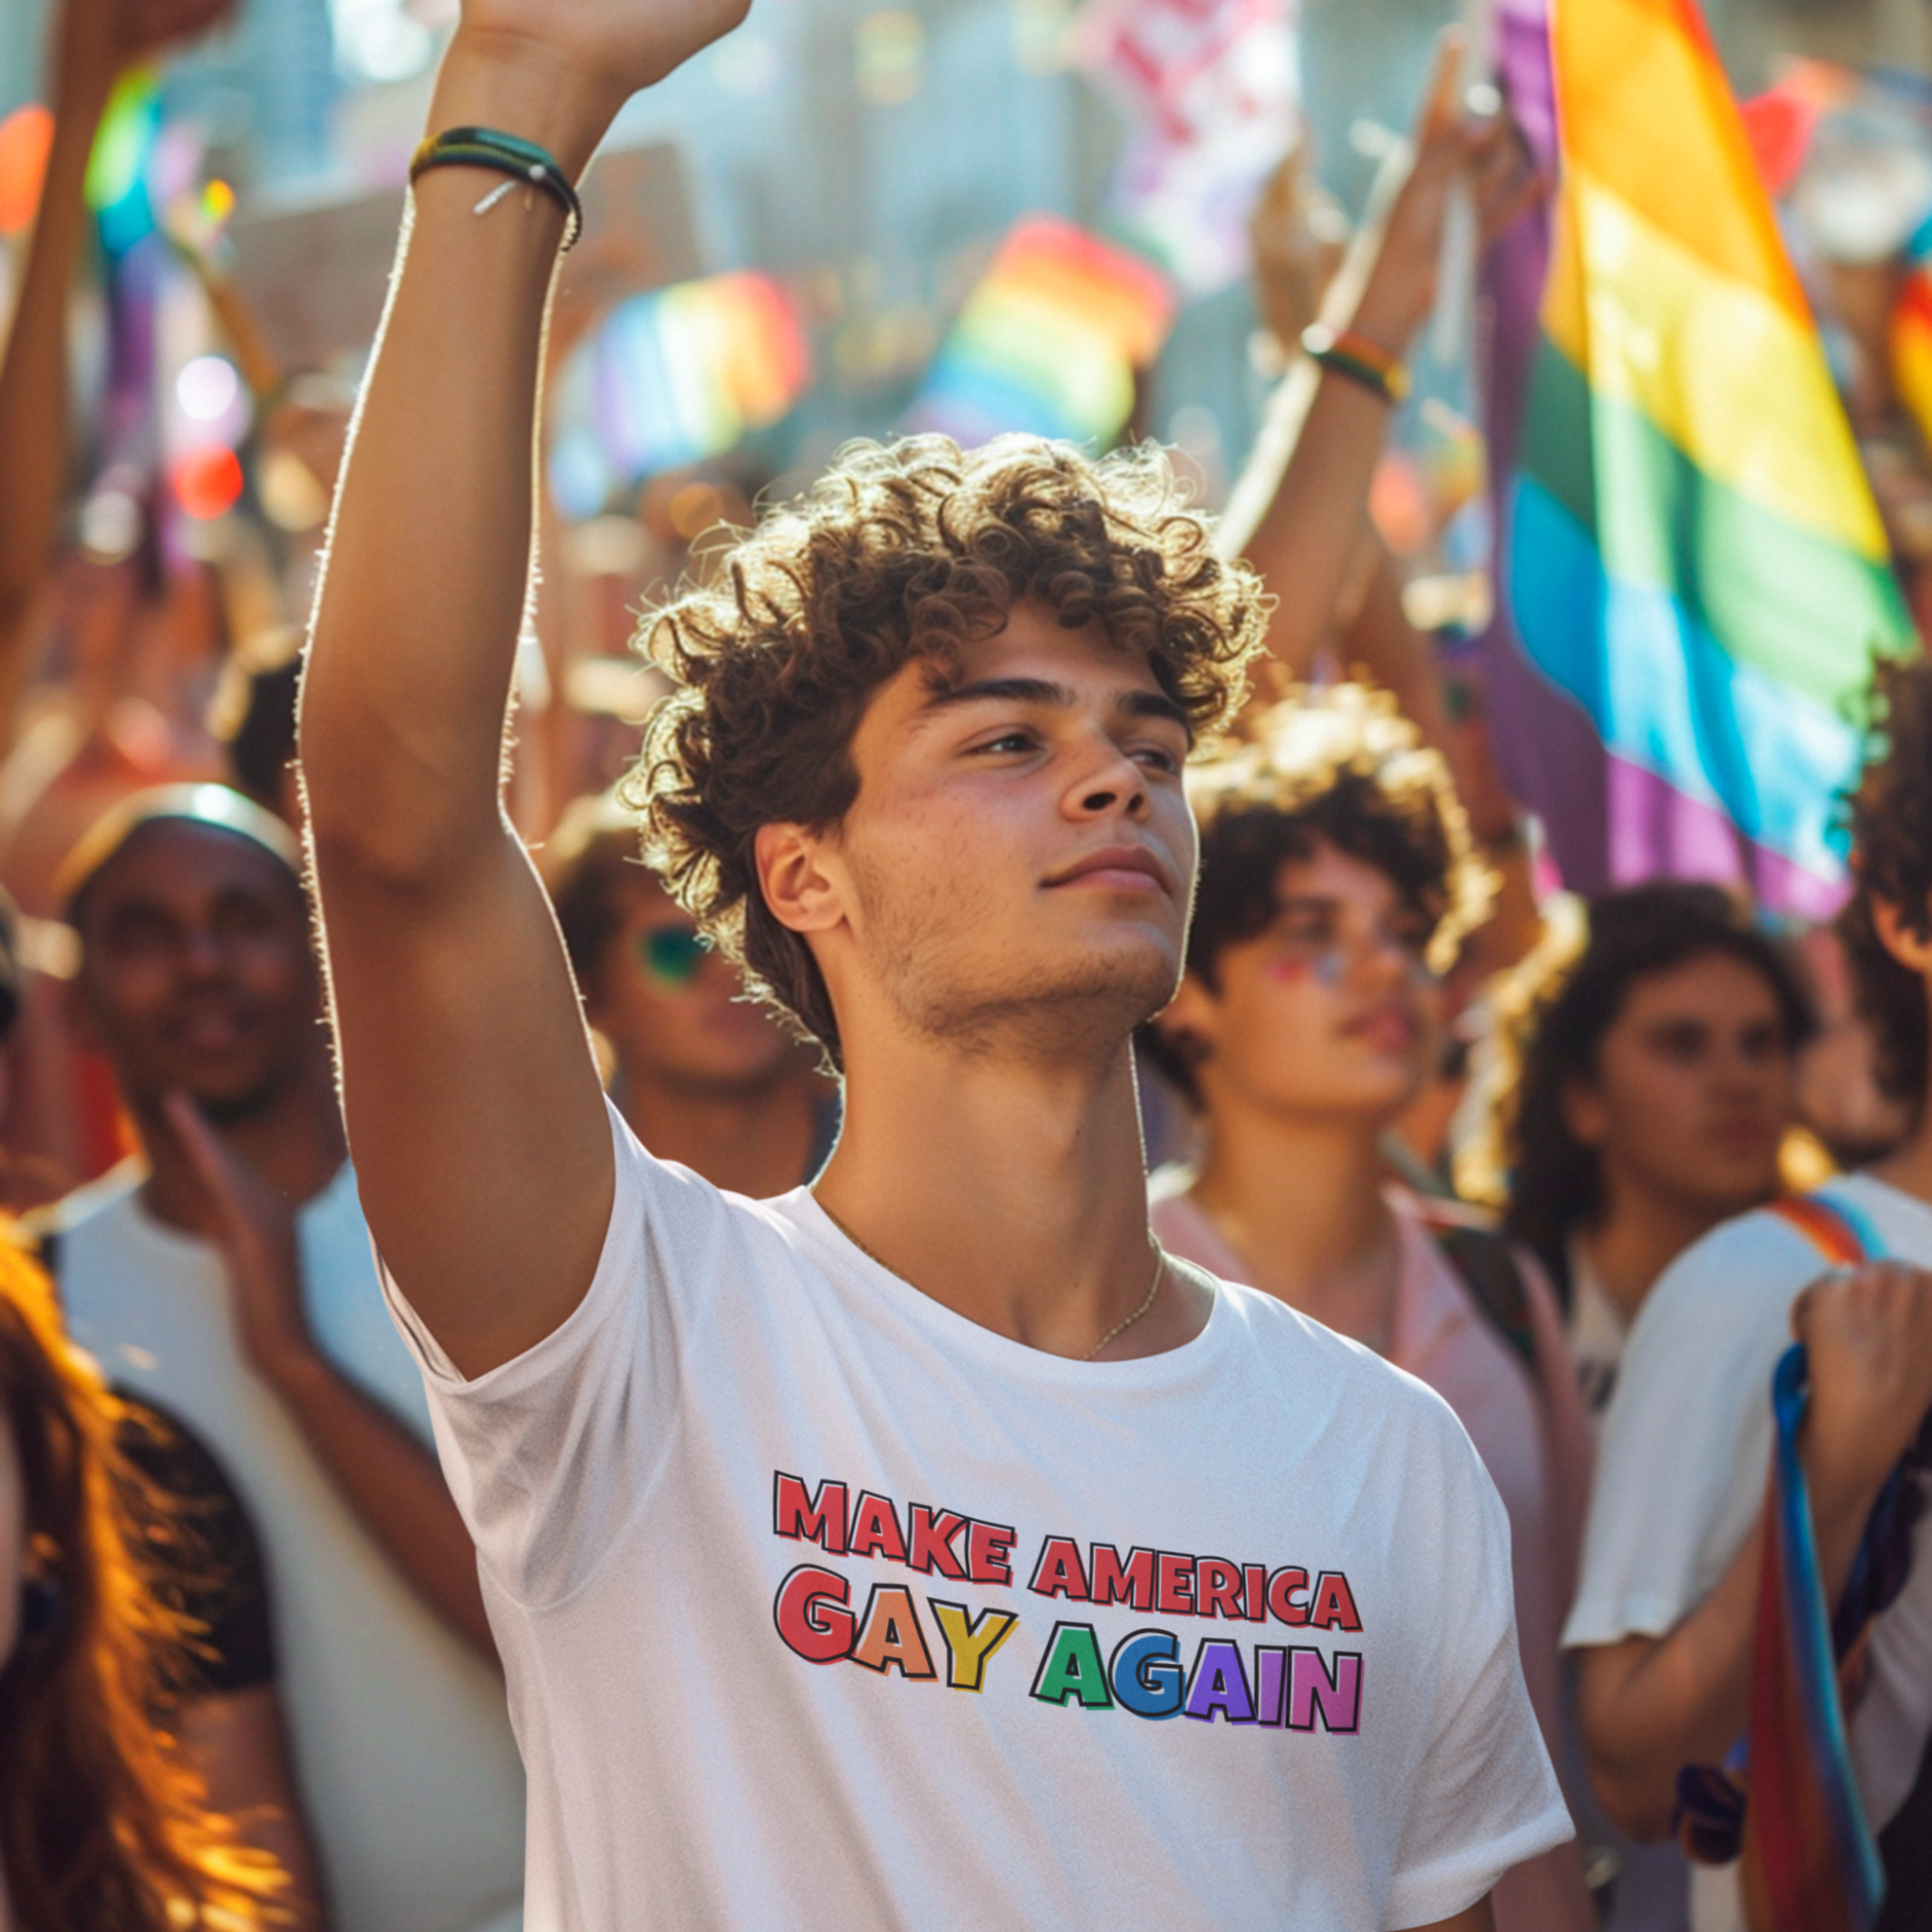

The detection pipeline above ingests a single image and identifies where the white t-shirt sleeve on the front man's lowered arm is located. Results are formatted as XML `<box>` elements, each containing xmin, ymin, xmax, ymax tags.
<box><xmin>1385</xmin><ymin>1383</ymin><xmax>1575</xmax><ymax>1928</ymax></box>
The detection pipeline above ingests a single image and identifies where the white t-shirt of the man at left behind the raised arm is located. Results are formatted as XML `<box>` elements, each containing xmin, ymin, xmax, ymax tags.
<box><xmin>56</xmin><ymin>1163</ymin><xmax>523</xmax><ymax>1932</ymax></box>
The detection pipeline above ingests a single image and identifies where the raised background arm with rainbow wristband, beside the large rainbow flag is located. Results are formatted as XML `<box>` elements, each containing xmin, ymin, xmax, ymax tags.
<box><xmin>1221</xmin><ymin>31</ymin><xmax>1536</xmax><ymax>687</ymax></box>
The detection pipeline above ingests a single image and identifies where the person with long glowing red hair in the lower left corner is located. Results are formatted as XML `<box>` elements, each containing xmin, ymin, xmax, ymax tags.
<box><xmin>0</xmin><ymin>1240</ymin><xmax>289</xmax><ymax>1932</ymax></box>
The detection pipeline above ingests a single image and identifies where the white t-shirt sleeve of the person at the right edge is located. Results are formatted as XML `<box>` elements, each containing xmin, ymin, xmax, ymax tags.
<box><xmin>1563</xmin><ymin>1213</ymin><xmax>1826</xmax><ymax>1648</ymax></box>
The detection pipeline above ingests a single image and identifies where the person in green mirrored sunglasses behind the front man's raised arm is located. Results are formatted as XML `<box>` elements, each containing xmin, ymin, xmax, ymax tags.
<box><xmin>539</xmin><ymin>796</ymin><xmax>839</xmax><ymax>1199</ymax></box>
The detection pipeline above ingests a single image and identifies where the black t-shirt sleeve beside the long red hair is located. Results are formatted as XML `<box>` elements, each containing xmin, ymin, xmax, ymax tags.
<box><xmin>118</xmin><ymin>1395</ymin><xmax>276</xmax><ymax>1702</ymax></box>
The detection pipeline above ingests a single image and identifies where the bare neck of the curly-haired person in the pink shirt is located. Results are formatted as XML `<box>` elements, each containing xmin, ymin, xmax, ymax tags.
<box><xmin>1192</xmin><ymin>1107</ymin><xmax>1399</xmax><ymax>1341</ymax></box>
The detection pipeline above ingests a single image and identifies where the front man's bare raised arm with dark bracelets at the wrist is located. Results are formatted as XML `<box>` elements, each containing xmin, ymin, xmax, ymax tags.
<box><xmin>302</xmin><ymin>0</ymin><xmax>744</xmax><ymax>1376</ymax></box>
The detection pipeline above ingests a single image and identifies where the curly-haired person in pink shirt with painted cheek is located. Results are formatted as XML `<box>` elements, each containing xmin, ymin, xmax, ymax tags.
<box><xmin>1142</xmin><ymin>684</ymin><xmax>1593</xmax><ymax>1932</ymax></box>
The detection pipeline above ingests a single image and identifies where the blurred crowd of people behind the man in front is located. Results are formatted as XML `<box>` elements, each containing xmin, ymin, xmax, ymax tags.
<box><xmin>0</xmin><ymin>0</ymin><xmax>1932</xmax><ymax>1932</ymax></box>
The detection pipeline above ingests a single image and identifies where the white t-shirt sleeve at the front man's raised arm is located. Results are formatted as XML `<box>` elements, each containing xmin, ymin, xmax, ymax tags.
<box><xmin>376</xmin><ymin>1103</ymin><xmax>730</xmax><ymax>1609</ymax></box>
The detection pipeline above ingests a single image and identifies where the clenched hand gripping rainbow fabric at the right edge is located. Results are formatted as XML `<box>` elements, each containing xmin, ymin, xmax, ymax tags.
<box><xmin>1791</xmin><ymin>1262</ymin><xmax>1932</xmax><ymax>1497</ymax></box>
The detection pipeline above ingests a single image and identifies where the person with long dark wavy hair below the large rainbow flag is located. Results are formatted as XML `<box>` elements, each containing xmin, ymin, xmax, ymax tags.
<box><xmin>1505</xmin><ymin>879</ymin><xmax>1812</xmax><ymax>1416</ymax></box>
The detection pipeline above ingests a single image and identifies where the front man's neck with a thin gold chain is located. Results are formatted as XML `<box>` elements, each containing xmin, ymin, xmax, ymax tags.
<box><xmin>817</xmin><ymin>1035</ymin><xmax>1207</xmax><ymax>1356</ymax></box>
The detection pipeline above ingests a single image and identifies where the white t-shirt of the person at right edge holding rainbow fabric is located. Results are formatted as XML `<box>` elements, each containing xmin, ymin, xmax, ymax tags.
<box><xmin>1563</xmin><ymin>1174</ymin><xmax>1932</xmax><ymax>1932</ymax></box>
